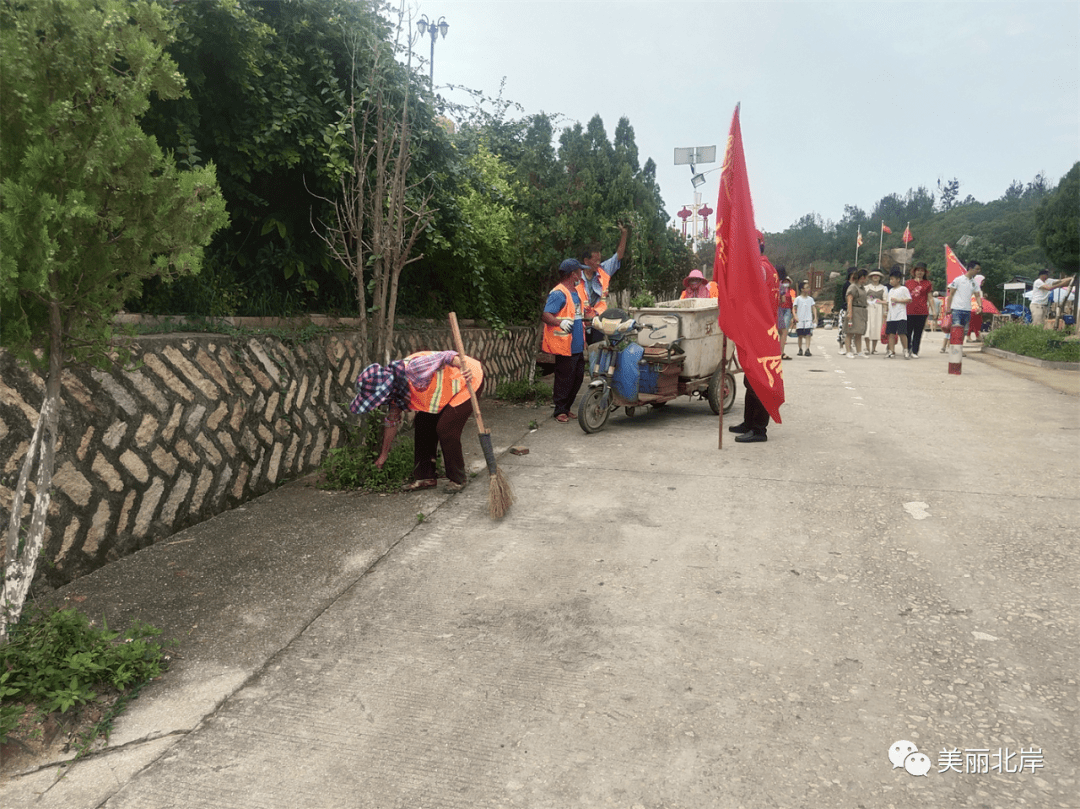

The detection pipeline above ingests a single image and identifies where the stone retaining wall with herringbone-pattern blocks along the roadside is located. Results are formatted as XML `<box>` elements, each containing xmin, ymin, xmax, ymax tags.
<box><xmin>0</xmin><ymin>326</ymin><xmax>537</xmax><ymax>589</ymax></box>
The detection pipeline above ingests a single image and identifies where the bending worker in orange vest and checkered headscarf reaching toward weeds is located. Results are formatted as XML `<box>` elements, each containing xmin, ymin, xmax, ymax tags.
<box><xmin>349</xmin><ymin>351</ymin><xmax>484</xmax><ymax>491</ymax></box>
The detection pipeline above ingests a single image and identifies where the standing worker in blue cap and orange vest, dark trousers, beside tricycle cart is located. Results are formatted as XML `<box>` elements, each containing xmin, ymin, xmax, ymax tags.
<box><xmin>540</xmin><ymin>258</ymin><xmax>585</xmax><ymax>424</ymax></box>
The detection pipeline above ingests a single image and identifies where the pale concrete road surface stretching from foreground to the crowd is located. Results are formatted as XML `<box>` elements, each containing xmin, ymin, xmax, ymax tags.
<box><xmin>0</xmin><ymin>347</ymin><xmax>1080</xmax><ymax>809</ymax></box>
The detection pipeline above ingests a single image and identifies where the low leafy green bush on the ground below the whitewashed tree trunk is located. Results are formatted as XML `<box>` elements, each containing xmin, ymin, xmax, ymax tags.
<box><xmin>0</xmin><ymin>609</ymin><xmax>165</xmax><ymax>743</ymax></box>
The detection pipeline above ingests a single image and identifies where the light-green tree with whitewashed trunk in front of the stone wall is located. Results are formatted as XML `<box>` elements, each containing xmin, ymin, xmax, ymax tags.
<box><xmin>0</xmin><ymin>0</ymin><xmax>228</xmax><ymax>639</ymax></box>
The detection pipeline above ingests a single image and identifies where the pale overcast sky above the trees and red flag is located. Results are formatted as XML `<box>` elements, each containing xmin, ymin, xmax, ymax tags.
<box><xmin>410</xmin><ymin>0</ymin><xmax>1080</xmax><ymax>232</ymax></box>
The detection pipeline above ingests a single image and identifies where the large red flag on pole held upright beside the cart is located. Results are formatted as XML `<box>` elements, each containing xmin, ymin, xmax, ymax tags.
<box><xmin>713</xmin><ymin>107</ymin><xmax>784</xmax><ymax>424</ymax></box>
